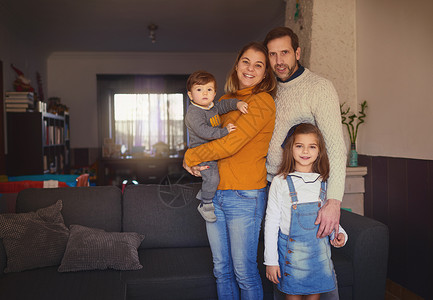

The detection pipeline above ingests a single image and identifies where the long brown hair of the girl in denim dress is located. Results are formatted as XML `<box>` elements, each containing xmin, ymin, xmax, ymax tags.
<box><xmin>278</xmin><ymin>123</ymin><xmax>329</xmax><ymax>181</ymax></box>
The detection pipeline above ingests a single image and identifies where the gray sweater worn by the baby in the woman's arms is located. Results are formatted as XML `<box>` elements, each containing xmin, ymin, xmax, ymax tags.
<box><xmin>185</xmin><ymin>99</ymin><xmax>239</xmax><ymax>148</ymax></box>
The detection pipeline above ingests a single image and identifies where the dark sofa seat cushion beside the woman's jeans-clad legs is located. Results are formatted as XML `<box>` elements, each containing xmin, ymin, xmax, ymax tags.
<box><xmin>121</xmin><ymin>247</ymin><xmax>217</xmax><ymax>300</ymax></box>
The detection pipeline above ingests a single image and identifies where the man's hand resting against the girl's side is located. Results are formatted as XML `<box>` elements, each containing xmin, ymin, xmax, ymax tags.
<box><xmin>314</xmin><ymin>199</ymin><xmax>341</xmax><ymax>238</ymax></box>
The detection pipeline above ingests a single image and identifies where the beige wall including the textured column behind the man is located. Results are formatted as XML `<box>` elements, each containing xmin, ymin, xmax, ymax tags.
<box><xmin>286</xmin><ymin>0</ymin><xmax>433</xmax><ymax>159</ymax></box>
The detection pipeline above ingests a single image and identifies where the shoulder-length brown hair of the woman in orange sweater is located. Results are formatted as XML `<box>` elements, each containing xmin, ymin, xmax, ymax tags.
<box><xmin>224</xmin><ymin>42</ymin><xmax>277</xmax><ymax>96</ymax></box>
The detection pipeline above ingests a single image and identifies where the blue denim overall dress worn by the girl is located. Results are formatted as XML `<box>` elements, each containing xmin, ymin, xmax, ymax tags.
<box><xmin>277</xmin><ymin>176</ymin><xmax>336</xmax><ymax>295</ymax></box>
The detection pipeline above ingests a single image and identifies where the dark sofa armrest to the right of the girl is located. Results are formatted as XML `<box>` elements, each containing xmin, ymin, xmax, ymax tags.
<box><xmin>335</xmin><ymin>210</ymin><xmax>388</xmax><ymax>300</ymax></box>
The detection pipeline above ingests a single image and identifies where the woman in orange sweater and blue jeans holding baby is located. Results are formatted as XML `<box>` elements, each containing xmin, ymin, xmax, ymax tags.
<box><xmin>184</xmin><ymin>42</ymin><xmax>276</xmax><ymax>299</ymax></box>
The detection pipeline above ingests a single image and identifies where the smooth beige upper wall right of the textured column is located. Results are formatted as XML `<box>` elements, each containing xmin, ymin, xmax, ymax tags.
<box><xmin>356</xmin><ymin>0</ymin><xmax>433</xmax><ymax>160</ymax></box>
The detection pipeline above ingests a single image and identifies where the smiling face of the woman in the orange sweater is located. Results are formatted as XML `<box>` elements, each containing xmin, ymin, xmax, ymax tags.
<box><xmin>236</xmin><ymin>48</ymin><xmax>266</xmax><ymax>89</ymax></box>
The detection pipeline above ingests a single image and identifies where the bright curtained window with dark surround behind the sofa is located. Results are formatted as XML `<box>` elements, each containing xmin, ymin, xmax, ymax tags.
<box><xmin>97</xmin><ymin>75</ymin><xmax>188</xmax><ymax>155</ymax></box>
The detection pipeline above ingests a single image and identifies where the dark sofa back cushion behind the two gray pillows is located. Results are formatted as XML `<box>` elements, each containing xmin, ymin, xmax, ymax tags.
<box><xmin>16</xmin><ymin>186</ymin><xmax>122</xmax><ymax>232</ymax></box>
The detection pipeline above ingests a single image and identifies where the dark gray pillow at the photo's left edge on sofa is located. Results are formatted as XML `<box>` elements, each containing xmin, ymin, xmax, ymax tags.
<box><xmin>0</xmin><ymin>200</ymin><xmax>69</xmax><ymax>273</ymax></box>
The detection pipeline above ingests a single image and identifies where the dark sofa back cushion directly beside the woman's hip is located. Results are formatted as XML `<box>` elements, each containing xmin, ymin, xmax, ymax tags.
<box><xmin>123</xmin><ymin>183</ymin><xmax>209</xmax><ymax>248</ymax></box>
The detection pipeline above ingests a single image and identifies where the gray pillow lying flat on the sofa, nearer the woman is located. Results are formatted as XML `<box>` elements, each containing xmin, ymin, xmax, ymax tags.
<box><xmin>58</xmin><ymin>225</ymin><xmax>144</xmax><ymax>272</ymax></box>
